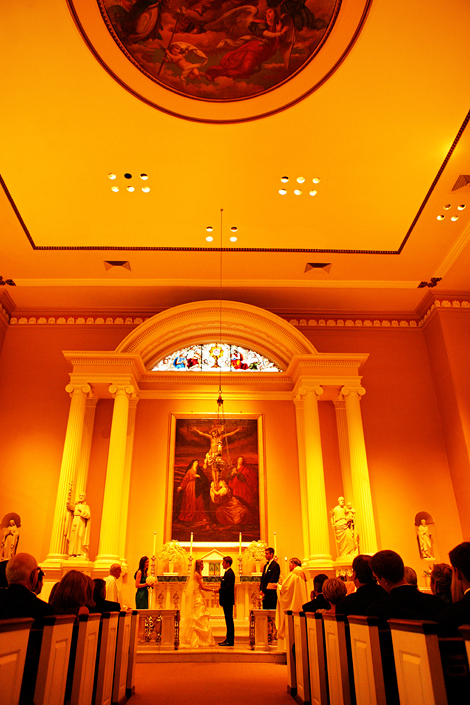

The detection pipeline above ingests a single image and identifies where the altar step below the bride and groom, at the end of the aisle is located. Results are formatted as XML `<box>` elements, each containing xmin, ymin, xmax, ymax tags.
<box><xmin>137</xmin><ymin>644</ymin><xmax>286</xmax><ymax>663</ymax></box>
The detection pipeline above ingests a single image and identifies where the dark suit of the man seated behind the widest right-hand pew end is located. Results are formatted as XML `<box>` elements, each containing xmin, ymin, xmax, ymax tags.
<box><xmin>365</xmin><ymin>585</ymin><xmax>444</xmax><ymax>621</ymax></box>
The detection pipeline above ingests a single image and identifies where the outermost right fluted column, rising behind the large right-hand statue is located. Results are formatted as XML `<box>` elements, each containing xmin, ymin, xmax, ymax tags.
<box><xmin>341</xmin><ymin>387</ymin><xmax>377</xmax><ymax>553</ymax></box>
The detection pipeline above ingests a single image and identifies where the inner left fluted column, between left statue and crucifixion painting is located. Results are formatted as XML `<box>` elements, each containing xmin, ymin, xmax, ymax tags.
<box><xmin>95</xmin><ymin>384</ymin><xmax>135</xmax><ymax>568</ymax></box>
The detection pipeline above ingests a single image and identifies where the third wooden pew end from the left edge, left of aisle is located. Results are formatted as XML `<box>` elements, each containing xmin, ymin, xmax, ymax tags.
<box><xmin>69</xmin><ymin>614</ymin><xmax>101</xmax><ymax>705</ymax></box>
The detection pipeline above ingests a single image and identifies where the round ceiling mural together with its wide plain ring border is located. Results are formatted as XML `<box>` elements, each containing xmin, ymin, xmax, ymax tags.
<box><xmin>69</xmin><ymin>0</ymin><xmax>371</xmax><ymax>122</ymax></box>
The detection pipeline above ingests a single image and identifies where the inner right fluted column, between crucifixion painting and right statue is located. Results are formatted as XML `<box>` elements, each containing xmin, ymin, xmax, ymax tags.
<box><xmin>299</xmin><ymin>387</ymin><xmax>332</xmax><ymax>565</ymax></box>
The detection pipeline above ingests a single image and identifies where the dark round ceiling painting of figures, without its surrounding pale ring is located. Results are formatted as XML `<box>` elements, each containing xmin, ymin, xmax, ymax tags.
<box><xmin>98</xmin><ymin>0</ymin><xmax>341</xmax><ymax>101</ymax></box>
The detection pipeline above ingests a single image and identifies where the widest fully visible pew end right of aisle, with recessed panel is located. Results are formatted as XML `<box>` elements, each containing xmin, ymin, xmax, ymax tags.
<box><xmin>388</xmin><ymin>619</ymin><xmax>448</xmax><ymax>705</ymax></box>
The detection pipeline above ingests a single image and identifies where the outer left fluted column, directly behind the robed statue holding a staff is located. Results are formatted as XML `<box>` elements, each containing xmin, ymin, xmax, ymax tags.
<box><xmin>46</xmin><ymin>384</ymin><xmax>91</xmax><ymax>565</ymax></box>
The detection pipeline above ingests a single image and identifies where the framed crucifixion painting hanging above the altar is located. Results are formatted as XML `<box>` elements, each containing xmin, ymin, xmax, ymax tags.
<box><xmin>165</xmin><ymin>416</ymin><xmax>265</xmax><ymax>544</ymax></box>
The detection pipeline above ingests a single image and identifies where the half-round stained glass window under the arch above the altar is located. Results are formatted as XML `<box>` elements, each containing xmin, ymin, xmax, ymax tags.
<box><xmin>152</xmin><ymin>343</ymin><xmax>281</xmax><ymax>372</ymax></box>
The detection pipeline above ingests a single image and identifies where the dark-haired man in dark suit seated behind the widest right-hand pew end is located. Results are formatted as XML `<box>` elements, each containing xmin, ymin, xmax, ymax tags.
<box><xmin>366</xmin><ymin>551</ymin><xmax>443</xmax><ymax>621</ymax></box>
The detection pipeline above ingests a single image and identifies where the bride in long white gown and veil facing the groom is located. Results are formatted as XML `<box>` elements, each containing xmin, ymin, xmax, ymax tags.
<box><xmin>181</xmin><ymin>560</ymin><xmax>215</xmax><ymax>649</ymax></box>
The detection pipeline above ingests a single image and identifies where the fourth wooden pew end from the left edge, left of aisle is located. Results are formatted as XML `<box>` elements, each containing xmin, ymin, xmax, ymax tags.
<box><xmin>93</xmin><ymin>612</ymin><xmax>119</xmax><ymax>705</ymax></box>
